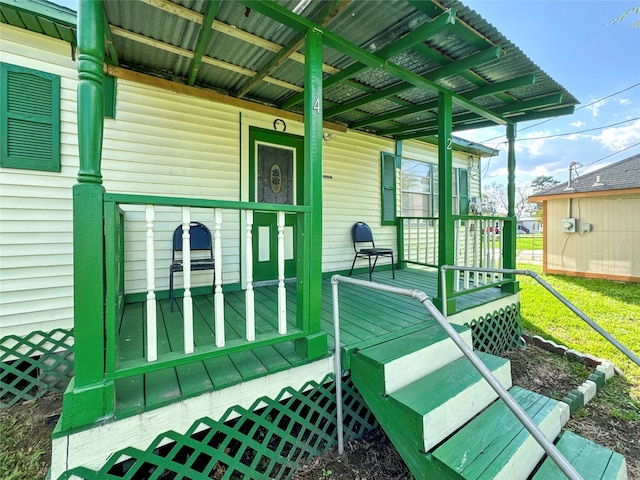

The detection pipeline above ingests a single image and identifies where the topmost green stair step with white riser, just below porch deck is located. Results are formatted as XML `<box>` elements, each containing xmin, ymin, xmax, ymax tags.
<box><xmin>358</xmin><ymin>323</ymin><xmax>473</xmax><ymax>395</ymax></box>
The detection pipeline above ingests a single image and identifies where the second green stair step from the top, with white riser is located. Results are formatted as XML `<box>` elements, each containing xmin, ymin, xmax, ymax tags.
<box><xmin>385</xmin><ymin>352</ymin><xmax>511</xmax><ymax>452</ymax></box>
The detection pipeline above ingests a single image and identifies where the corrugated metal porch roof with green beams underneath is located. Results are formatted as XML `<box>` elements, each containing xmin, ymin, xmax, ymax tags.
<box><xmin>0</xmin><ymin>0</ymin><xmax>578</xmax><ymax>144</ymax></box>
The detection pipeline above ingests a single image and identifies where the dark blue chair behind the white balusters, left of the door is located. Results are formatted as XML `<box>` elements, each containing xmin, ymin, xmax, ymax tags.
<box><xmin>169</xmin><ymin>222</ymin><xmax>216</xmax><ymax>312</ymax></box>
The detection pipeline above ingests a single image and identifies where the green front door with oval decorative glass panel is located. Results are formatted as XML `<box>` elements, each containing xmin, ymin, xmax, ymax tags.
<box><xmin>249</xmin><ymin>128</ymin><xmax>304</xmax><ymax>282</ymax></box>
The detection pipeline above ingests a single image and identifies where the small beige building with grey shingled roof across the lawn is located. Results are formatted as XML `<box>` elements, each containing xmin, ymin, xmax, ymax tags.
<box><xmin>529</xmin><ymin>154</ymin><xmax>640</xmax><ymax>282</ymax></box>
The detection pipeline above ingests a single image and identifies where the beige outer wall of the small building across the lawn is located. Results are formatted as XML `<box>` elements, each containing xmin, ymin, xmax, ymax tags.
<box><xmin>544</xmin><ymin>195</ymin><xmax>640</xmax><ymax>279</ymax></box>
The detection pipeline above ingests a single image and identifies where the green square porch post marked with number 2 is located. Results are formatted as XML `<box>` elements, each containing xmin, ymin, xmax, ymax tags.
<box><xmin>434</xmin><ymin>92</ymin><xmax>456</xmax><ymax>314</ymax></box>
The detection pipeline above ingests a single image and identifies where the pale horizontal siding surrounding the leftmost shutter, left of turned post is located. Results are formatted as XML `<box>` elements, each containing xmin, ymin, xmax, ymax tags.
<box><xmin>0</xmin><ymin>24</ymin><xmax>78</xmax><ymax>337</ymax></box>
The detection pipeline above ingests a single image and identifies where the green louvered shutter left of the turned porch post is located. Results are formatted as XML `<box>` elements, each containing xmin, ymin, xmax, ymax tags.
<box><xmin>0</xmin><ymin>63</ymin><xmax>60</xmax><ymax>172</ymax></box>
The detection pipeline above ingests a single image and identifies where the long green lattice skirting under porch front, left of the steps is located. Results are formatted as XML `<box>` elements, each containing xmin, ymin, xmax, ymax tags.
<box><xmin>60</xmin><ymin>377</ymin><xmax>377</xmax><ymax>480</ymax></box>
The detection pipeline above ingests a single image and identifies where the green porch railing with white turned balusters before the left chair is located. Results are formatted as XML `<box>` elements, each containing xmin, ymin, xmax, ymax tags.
<box><xmin>105</xmin><ymin>194</ymin><xmax>318</xmax><ymax>381</ymax></box>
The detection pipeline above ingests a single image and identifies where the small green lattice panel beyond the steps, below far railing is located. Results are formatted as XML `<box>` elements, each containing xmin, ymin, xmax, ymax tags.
<box><xmin>465</xmin><ymin>303</ymin><xmax>522</xmax><ymax>355</ymax></box>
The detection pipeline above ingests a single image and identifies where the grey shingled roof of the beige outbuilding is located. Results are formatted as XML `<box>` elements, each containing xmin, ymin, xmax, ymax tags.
<box><xmin>529</xmin><ymin>154</ymin><xmax>640</xmax><ymax>202</ymax></box>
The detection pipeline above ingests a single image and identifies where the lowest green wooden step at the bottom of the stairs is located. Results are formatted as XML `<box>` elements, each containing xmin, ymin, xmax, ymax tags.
<box><xmin>532</xmin><ymin>431</ymin><xmax>627</xmax><ymax>480</ymax></box>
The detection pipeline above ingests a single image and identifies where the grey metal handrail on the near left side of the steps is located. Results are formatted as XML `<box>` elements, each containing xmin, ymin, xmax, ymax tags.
<box><xmin>331</xmin><ymin>275</ymin><xmax>583</xmax><ymax>480</ymax></box>
